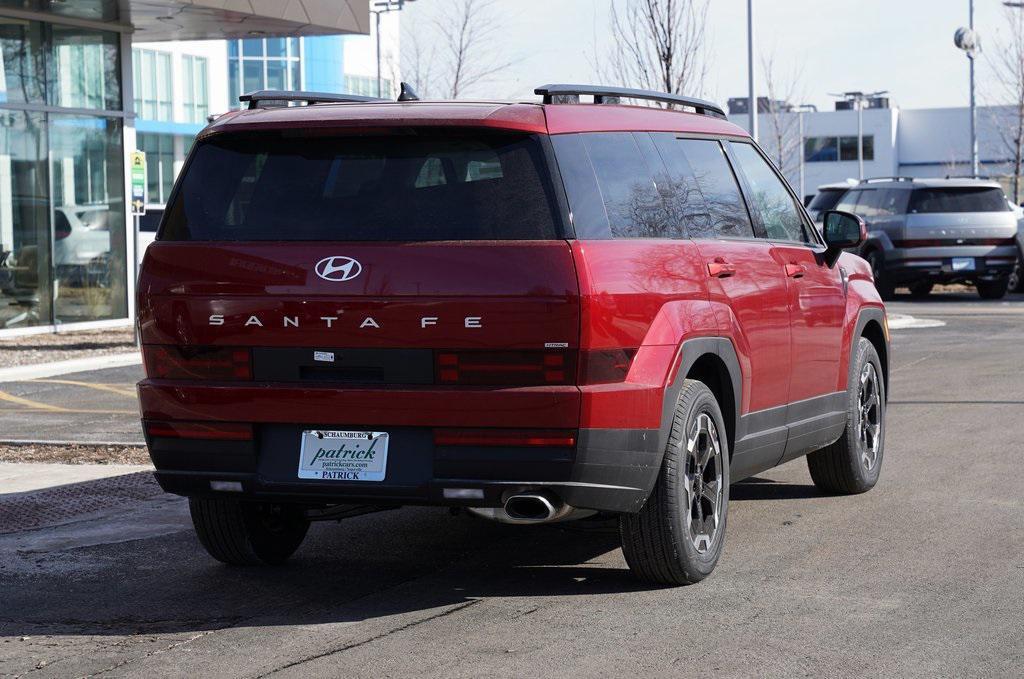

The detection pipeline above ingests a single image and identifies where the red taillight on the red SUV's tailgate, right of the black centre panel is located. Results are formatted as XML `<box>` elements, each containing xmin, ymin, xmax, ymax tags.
<box><xmin>434</xmin><ymin>349</ymin><xmax>575</xmax><ymax>386</ymax></box>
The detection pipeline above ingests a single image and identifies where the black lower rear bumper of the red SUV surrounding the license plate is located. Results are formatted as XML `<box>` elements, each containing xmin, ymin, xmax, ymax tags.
<box><xmin>147</xmin><ymin>424</ymin><xmax>660</xmax><ymax>512</ymax></box>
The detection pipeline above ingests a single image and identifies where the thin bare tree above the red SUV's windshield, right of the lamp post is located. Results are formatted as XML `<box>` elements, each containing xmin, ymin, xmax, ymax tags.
<box><xmin>759</xmin><ymin>52</ymin><xmax>804</xmax><ymax>179</ymax></box>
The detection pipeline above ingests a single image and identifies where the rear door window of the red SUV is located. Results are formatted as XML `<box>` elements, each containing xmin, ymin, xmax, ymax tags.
<box><xmin>670</xmin><ymin>139</ymin><xmax>754</xmax><ymax>238</ymax></box>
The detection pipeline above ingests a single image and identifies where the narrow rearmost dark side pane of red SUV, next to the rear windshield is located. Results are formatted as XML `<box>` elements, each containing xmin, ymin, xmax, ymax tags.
<box><xmin>551</xmin><ymin>134</ymin><xmax>611</xmax><ymax>240</ymax></box>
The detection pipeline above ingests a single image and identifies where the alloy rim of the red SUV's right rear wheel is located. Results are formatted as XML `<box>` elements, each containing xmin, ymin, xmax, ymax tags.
<box><xmin>685</xmin><ymin>413</ymin><xmax>724</xmax><ymax>554</ymax></box>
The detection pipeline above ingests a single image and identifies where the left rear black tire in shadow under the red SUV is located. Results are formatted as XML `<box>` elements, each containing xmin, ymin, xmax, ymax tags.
<box><xmin>188</xmin><ymin>498</ymin><xmax>309</xmax><ymax>565</ymax></box>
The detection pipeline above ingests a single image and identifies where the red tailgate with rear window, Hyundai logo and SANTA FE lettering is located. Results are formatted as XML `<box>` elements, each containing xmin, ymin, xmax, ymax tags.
<box><xmin>139</xmin><ymin>128</ymin><xmax>580</xmax><ymax>386</ymax></box>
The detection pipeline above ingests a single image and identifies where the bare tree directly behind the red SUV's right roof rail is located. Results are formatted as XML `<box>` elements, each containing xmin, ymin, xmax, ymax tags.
<box><xmin>595</xmin><ymin>0</ymin><xmax>708</xmax><ymax>102</ymax></box>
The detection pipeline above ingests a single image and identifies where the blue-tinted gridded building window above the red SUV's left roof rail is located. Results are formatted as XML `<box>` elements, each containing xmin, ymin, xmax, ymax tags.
<box><xmin>227</xmin><ymin>38</ymin><xmax>302</xmax><ymax>109</ymax></box>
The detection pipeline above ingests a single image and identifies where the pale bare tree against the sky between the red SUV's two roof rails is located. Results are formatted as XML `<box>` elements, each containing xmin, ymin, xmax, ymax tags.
<box><xmin>402</xmin><ymin>0</ymin><xmax>516</xmax><ymax>99</ymax></box>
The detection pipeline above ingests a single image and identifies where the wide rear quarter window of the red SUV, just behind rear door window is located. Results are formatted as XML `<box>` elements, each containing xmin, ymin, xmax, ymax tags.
<box><xmin>583</xmin><ymin>132</ymin><xmax>667</xmax><ymax>238</ymax></box>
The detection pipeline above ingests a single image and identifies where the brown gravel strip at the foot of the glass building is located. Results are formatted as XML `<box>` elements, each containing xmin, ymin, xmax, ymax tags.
<box><xmin>0</xmin><ymin>328</ymin><xmax>135</xmax><ymax>368</ymax></box>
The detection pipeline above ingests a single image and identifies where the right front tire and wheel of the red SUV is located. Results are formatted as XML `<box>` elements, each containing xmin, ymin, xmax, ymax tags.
<box><xmin>807</xmin><ymin>337</ymin><xmax>886</xmax><ymax>495</ymax></box>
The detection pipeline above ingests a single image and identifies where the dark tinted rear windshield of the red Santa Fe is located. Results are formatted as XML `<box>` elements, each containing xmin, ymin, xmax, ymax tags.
<box><xmin>160</xmin><ymin>133</ymin><xmax>560</xmax><ymax>241</ymax></box>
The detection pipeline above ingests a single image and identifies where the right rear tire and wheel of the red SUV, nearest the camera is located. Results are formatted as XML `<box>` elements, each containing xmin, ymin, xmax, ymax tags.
<box><xmin>618</xmin><ymin>380</ymin><xmax>729</xmax><ymax>585</ymax></box>
